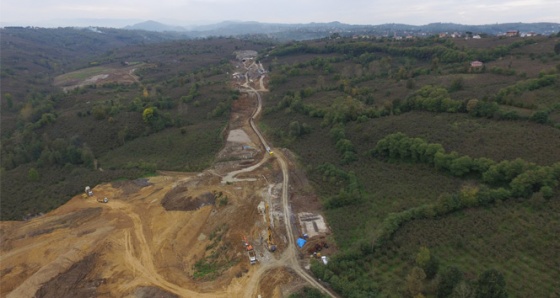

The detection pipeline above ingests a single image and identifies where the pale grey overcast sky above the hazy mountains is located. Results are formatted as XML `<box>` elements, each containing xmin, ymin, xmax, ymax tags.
<box><xmin>0</xmin><ymin>0</ymin><xmax>560</xmax><ymax>27</ymax></box>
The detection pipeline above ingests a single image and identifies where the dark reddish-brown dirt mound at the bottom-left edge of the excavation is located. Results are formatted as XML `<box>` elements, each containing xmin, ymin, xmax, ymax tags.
<box><xmin>35</xmin><ymin>254</ymin><xmax>102</xmax><ymax>298</ymax></box>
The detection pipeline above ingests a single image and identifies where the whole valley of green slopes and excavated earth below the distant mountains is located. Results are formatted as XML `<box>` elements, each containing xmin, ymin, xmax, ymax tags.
<box><xmin>0</xmin><ymin>28</ymin><xmax>560</xmax><ymax>297</ymax></box>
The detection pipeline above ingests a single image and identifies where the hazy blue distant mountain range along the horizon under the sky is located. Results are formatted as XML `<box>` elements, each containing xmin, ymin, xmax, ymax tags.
<box><xmin>124</xmin><ymin>21</ymin><xmax>560</xmax><ymax>40</ymax></box>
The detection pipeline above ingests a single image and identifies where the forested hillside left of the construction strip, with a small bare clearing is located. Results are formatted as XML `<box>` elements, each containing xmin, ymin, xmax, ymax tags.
<box><xmin>0</xmin><ymin>28</ymin><xmax>270</xmax><ymax>220</ymax></box>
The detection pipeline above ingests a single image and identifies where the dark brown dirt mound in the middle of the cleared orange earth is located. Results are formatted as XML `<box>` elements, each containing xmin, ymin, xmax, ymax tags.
<box><xmin>161</xmin><ymin>186</ymin><xmax>216</xmax><ymax>211</ymax></box>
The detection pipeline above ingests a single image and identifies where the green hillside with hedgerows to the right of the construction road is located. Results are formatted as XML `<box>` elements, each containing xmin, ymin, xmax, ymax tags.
<box><xmin>262</xmin><ymin>37</ymin><xmax>560</xmax><ymax>297</ymax></box>
